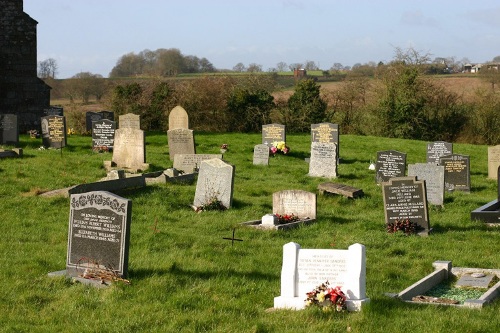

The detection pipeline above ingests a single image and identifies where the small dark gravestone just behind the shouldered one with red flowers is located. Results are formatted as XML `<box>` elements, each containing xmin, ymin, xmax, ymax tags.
<box><xmin>375</xmin><ymin>150</ymin><xmax>406</xmax><ymax>184</ymax></box>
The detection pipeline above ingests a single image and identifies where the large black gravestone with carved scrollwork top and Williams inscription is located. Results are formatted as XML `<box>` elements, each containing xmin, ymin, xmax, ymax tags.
<box><xmin>66</xmin><ymin>191</ymin><xmax>132</xmax><ymax>277</ymax></box>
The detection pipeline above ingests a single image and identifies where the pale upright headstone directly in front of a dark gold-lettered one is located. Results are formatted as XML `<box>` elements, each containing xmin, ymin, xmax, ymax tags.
<box><xmin>309</xmin><ymin>142</ymin><xmax>337</xmax><ymax>178</ymax></box>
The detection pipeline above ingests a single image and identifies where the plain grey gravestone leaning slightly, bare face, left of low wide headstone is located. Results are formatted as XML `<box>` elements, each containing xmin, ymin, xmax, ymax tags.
<box><xmin>193</xmin><ymin>158</ymin><xmax>234</xmax><ymax>208</ymax></box>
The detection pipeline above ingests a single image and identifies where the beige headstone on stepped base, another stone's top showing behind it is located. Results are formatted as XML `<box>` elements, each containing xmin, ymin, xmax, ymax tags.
<box><xmin>112</xmin><ymin>128</ymin><xmax>148</xmax><ymax>170</ymax></box>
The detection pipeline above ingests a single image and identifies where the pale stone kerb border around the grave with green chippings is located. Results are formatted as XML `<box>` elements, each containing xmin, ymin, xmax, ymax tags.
<box><xmin>386</xmin><ymin>261</ymin><xmax>500</xmax><ymax>309</ymax></box>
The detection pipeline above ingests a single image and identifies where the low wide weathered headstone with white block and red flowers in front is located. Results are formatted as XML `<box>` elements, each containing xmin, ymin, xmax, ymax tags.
<box><xmin>273</xmin><ymin>190</ymin><xmax>316</xmax><ymax>219</ymax></box>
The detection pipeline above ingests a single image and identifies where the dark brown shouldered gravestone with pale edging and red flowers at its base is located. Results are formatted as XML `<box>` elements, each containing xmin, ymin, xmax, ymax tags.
<box><xmin>382</xmin><ymin>177</ymin><xmax>429</xmax><ymax>235</ymax></box>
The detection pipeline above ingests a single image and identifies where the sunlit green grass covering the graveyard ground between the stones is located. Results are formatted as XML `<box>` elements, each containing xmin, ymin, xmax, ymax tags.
<box><xmin>0</xmin><ymin>133</ymin><xmax>500</xmax><ymax>332</ymax></box>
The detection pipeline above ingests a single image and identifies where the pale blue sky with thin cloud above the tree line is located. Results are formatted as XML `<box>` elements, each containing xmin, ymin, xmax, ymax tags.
<box><xmin>24</xmin><ymin>0</ymin><xmax>500</xmax><ymax>78</ymax></box>
